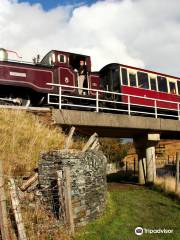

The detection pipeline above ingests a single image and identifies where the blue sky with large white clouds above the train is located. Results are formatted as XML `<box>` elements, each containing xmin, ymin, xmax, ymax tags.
<box><xmin>0</xmin><ymin>0</ymin><xmax>180</xmax><ymax>76</ymax></box>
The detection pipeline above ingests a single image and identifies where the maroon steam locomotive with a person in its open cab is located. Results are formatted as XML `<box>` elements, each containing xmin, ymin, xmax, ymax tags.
<box><xmin>0</xmin><ymin>48</ymin><xmax>100</xmax><ymax>106</ymax></box>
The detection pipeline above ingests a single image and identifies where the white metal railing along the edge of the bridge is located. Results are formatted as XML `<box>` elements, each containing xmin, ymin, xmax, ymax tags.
<box><xmin>48</xmin><ymin>83</ymin><xmax>180</xmax><ymax>120</ymax></box>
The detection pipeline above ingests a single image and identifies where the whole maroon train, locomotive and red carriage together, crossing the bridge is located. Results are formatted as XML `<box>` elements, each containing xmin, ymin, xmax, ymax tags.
<box><xmin>0</xmin><ymin>48</ymin><xmax>180</xmax><ymax>116</ymax></box>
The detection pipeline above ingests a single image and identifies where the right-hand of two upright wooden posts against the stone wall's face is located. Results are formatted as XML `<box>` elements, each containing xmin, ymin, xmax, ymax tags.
<box><xmin>64</xmin><ymin>167</ymin><xmax>74</xmax><ymax>235</ymax></box>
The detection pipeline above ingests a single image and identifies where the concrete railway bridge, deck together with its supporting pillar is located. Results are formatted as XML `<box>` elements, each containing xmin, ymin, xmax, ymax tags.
<box><xmin>52</xmin><ymin>109</ymin><xmax>180</xmax><ymax>184</ymax></box>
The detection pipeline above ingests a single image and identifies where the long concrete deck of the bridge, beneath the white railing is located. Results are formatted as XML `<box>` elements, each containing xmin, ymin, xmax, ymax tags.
<box><xmin>52</xmin><ymin>109</ymin><xmax>180</xmax><ymax>139</ymax></box>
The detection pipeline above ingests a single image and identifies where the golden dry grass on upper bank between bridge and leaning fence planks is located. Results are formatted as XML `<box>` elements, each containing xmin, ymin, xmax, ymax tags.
<box><xmin>0</xmin><ymin>109</ymin><xmax>65</xmax><ymax>176</ymax></box>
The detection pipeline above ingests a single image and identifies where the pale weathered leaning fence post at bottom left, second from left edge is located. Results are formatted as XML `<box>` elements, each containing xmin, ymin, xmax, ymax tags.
<box><xmin>9</xmin><ymin>178</ymin><xmax>27</xmax><ymax>240</ymax></box>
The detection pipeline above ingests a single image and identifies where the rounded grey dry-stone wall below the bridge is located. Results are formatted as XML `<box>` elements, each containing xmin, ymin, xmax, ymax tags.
<box><xmin>39</xmin><ymin>150</ymin><xmax>107</xmax><ymax>227</ymax></box>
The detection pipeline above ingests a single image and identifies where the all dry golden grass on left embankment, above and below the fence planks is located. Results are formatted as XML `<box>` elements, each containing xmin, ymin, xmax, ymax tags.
<box><xmin>0</xmin><ymin>109</ymin><xmax>69</xmax><ymax>240</ymax></box>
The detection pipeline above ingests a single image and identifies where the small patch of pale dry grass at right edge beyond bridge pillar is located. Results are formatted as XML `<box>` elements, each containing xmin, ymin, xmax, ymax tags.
<box><xmin>155</xmin><ymin>176</ymin><xmax>180</xmax><ymax>197</ymax></box>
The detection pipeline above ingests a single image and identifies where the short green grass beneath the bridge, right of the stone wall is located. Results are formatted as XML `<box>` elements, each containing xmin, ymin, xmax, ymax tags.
<box><xmin>75</xmin><ymin>188</ymin><xmax>180</xmax><ymax>240</ymax></box>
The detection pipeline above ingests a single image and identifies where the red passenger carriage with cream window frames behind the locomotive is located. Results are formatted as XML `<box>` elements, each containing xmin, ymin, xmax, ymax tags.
<box><xmin>100</xmin><ymin>63</ymin><xmax>180</xmax><ymax>113</ymax></box>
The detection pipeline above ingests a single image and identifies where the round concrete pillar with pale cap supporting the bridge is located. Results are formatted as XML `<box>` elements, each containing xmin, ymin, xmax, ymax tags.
<box><xmin>134</xmin><ymin>134</ymin><xmax>160</xmax><ymax>184</ymax></box>
